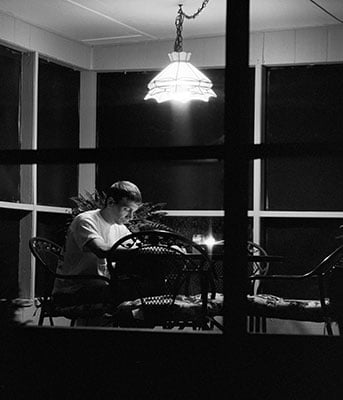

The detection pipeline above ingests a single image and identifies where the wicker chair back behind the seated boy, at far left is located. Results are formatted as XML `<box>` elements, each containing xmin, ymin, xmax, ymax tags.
<box><xmin>29</xmin><ymin>237</ymin><xmax>63</xmax><ymax>297</ymax></box>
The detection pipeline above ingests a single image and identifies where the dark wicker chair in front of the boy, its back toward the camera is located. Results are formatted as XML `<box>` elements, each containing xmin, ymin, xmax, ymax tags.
<box><xmin>107</xmin><ymin>230</ymin><xmax>222</xmax><ymax>330</ymax></box>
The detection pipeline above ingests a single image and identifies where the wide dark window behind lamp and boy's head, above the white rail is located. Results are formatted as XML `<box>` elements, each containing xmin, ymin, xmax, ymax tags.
<box><xmin>96</xmin><ymin>69</ymin><xmax>254</xmax><ymax>210</ymax></box>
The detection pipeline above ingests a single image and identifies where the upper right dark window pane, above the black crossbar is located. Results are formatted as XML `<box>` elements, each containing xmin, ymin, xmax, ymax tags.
<box><xmin>265</xmin><ymin>64</ymin><xmax>343</xmax><ymax>143</ymax></box>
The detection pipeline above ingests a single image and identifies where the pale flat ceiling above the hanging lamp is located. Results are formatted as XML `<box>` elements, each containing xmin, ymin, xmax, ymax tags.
<box><xmin>0</xmin><ymin>0</ymin><xmax>343</xmax><ymax>46</ymax></box>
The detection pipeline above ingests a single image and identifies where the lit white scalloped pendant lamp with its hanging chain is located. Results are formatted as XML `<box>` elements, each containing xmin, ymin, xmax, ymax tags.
<box><xmin>144</xmin><ymin>0</ymin><xmax>217</xmax><ymax>103</ymax></box>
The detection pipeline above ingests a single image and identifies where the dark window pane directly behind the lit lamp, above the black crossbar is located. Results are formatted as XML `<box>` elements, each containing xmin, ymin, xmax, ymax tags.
<box><xmin>97</xmin><ymin>69</ymin><xmax>254</xmax><ymax>147</ymax></box>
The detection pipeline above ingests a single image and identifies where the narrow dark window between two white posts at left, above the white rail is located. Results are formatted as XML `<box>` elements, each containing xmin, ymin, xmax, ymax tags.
<box><xmin>38</xmin><ymin>60</ymin><xmax>80</xmax><ymax>206</ymax></box>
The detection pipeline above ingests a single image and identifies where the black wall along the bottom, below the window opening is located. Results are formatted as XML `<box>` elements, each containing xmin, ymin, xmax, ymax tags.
<box><xmin>0</xmin><ymin>328</ymin><xmax>343</xmax><ymax>400</ymax></box>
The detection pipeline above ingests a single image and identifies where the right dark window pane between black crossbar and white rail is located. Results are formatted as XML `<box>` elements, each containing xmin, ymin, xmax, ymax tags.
<box><xmin>265</xmin><ymin>157</ymin><xmax>343</xmax><ymax>211</ymax></box>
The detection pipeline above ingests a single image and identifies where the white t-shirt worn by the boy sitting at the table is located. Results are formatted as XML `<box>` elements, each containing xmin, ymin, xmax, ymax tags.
<box><xmin>53</xmin><ymin>209</ymin><xmax>131</xmax><ymax>293</ymax></box>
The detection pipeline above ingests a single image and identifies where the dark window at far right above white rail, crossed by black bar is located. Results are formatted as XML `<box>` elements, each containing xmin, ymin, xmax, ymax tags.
<box><xmin>264</xmin><ymin>64</ymin><xmax>343</xmax><ymax>211</ymax></box>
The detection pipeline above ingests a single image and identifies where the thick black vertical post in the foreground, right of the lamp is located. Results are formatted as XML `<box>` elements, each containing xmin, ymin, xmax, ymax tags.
<box><xmin>224</xmin><ymin>0</ymin><xmax>250</xmax><ymax>336</ymax></box>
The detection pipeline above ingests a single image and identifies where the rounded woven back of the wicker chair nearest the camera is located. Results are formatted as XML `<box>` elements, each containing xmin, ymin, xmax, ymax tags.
<box><xmin>109</xmin><ymin>230</ymin><xmax>214</xmax><ymax>309</ymax></box>
